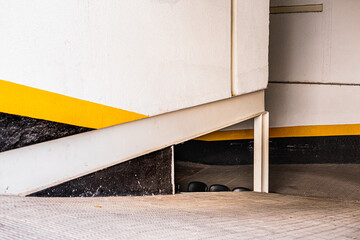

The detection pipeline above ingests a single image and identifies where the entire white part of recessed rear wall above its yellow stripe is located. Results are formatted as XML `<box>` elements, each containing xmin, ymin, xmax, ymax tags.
<box><xmin>225</xmin><ymin>0</ymin><xmax>360</xmax><ymax>130</ymax></box>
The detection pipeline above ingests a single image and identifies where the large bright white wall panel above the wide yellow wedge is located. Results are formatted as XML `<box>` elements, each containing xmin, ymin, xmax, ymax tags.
<box><xmin>0</xmin><ymin>0</ymin><xmax>231</xmax><ymax>115</ymax></box>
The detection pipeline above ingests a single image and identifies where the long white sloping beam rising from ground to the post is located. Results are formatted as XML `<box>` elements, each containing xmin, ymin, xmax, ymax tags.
<box><xmin>0</xmin><ymin>91</ymin><xmax>265</xmax><ymax>196</ymax></box>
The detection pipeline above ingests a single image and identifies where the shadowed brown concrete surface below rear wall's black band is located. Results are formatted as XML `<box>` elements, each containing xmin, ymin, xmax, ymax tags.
<box><xmin>175</xmin><ymin>162</ymin><xmax>360</xmax><ymax>200</ymax></box>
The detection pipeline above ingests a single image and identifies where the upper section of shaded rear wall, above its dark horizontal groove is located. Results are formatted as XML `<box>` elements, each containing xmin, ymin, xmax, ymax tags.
<box><xmin>270</xmin><ymin>0</ymin><xmax>360</xmax><ymax>84</ymax></box>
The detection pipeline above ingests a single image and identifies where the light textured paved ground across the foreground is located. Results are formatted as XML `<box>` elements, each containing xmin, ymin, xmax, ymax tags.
<box><xmin>0</xmin><ymin>192</ymin><xmax>360</xmax><ymax>240</ymax></box>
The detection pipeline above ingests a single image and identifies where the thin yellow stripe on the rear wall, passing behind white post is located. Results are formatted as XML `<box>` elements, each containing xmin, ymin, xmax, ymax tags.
<box><xmin>195</xmin><ymin>124</ymin><xmax>360</xmax><ymax>141</ymax></box>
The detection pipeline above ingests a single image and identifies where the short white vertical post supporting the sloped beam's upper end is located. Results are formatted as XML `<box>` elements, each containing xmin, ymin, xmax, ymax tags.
<box><xmin>254</xmin><ymin>112</ymin><xmax>269</xmax><ymax>193</ymax></box>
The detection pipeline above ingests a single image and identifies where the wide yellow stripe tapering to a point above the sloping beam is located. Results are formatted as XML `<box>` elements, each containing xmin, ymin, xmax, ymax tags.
<box><xmin>0</xmin><ymin>80</ymin><xmax>148</xmax><ymax>129</ymax></box>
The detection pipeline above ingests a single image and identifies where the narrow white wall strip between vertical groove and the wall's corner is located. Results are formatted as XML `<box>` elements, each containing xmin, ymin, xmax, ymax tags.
<box><xmin>232</xmin><ymin>0</ymin><xmax>269</xmax><ymax>95</ymax></box>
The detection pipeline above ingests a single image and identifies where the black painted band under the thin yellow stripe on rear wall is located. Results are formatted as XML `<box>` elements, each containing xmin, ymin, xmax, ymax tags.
<box><xmin>175</xmin><ymin>136</ymin><xmax>360</xmax><ymax>165</ymax></box>
